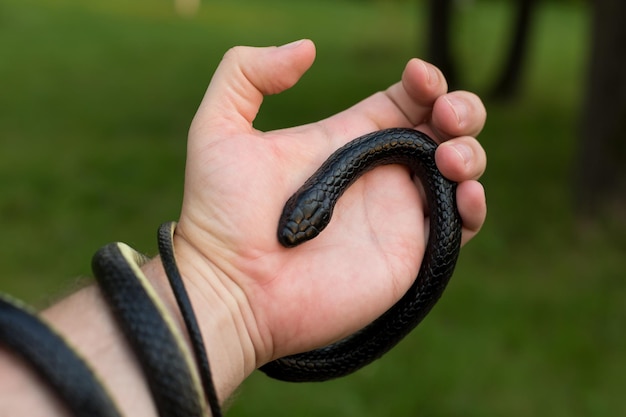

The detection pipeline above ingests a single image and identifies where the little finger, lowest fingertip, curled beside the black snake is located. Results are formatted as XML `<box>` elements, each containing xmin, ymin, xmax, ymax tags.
<box><xmin>456</xmin><ymin>181</ymin><xmax>487</xmax><ymax>245</ymax></box>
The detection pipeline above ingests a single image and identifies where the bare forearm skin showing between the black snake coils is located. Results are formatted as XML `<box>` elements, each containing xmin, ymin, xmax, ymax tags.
<box><xmin>0</xmin><ymin>255</ymin><xmax>254</xmax><ymax>417</ymax></box>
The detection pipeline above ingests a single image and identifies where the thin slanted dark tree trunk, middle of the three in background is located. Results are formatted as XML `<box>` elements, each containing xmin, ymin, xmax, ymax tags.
<box><xmin>492</xmin><ymin>0</ymin><xmax>537</xmax><ymax>100</ymax></box>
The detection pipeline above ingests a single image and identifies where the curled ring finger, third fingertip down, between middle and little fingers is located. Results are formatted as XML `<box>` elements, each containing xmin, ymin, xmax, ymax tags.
<box><xmin>435</xmin><ymin>136</ymin><xmax>487</xmax><ymax>182</ymax></box>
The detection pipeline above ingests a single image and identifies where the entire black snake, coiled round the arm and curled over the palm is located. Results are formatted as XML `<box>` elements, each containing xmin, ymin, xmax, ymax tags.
<box><xmin>0</xmin><ymin>128</ymin><xmax>461</xmax><ymax>417</ymax></box>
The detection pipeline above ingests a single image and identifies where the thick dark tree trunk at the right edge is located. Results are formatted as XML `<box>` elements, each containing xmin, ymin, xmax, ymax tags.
<box><xmin>574</xmin><ymin>0</ymin><xmax>626</xmax><ymax>220</ymax></box>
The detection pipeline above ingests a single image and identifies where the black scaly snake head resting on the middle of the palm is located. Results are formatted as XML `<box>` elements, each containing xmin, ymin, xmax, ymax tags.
<box><xmin>278</xmin><ymin>191</ymin><xmax>332</xmax><ymax>248</ymax></box>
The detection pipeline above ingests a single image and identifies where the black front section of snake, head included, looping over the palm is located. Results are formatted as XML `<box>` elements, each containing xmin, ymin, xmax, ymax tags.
<box><xmin>260</xmin><ymin>128</ymin><xmax>462</xmax><ymax>382</ymax></box>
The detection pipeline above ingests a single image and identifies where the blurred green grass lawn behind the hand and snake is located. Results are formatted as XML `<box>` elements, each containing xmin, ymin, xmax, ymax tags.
<box><xmin>0</xmin><ymin>0</ymin><xmax>626</xmax><ymax>417</ymax></box>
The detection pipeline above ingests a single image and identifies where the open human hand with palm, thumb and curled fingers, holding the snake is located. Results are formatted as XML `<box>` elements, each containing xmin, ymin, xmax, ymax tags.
<box><xmin>175</xmin><ymin>41</ymin><xmax>486</xmax><ymax>384</ymax></box>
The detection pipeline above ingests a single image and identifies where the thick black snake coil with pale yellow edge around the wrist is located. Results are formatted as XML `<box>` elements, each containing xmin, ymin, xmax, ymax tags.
<box><xmin>92</xmin><ymin>243</ymin><xmax>207</xmax><ymax>417</ymax></box>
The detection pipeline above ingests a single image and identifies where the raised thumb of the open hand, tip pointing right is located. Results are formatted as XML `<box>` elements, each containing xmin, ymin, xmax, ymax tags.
<box><xmin>190</xmin><ymin>39</ymin><xmax>315</xmax><ymax>137</ymax></box>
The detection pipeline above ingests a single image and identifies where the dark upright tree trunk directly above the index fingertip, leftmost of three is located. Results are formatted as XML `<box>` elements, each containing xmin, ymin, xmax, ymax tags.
<box><xmin>427</xmin><ymin>0</ymin><xmax>457</xmax><ymax>86</ymax></box>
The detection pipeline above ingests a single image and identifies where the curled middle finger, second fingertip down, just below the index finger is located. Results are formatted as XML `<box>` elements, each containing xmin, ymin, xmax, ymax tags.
<box><xmin>428</xmin><ymin>91</ymin><xmax>487</xmax><ymax>141</ymax></box>
